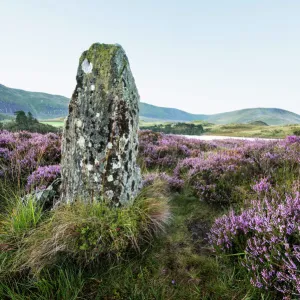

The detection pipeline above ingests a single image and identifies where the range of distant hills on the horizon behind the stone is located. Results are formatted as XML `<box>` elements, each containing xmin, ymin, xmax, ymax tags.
<box><xmin>0</xmin><ymin>84</ymin><xmax>300</xmax><ymax>125</ymax></box>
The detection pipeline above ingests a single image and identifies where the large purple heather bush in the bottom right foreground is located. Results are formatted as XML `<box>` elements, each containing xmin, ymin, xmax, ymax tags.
<box><xmin>209</xmin><ymin>193</ymin><xmax>300</xmax><ymax>297</ymax></box>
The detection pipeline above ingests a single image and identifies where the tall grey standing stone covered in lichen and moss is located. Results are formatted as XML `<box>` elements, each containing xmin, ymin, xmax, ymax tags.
<box><xmin>60</xmin><ymin>44</ymin><xmax>141</xmax><ymax>206</ymax></box>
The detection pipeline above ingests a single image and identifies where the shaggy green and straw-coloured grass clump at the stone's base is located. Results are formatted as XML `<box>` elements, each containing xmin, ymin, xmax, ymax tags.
<box><xmin>17</xmin><ymin>182</ymin><xmax>170</xmax><ymax>273</ymax></box>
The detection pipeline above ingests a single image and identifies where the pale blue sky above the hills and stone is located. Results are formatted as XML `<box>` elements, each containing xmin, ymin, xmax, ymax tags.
<box><xmin>0</xmin><ymin>0</ymin><xmax>300</xmax><ymax>114</ymax></box>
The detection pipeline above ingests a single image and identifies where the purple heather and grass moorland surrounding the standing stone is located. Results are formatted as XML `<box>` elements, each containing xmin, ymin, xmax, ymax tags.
<box><xmin>0</xmin><ymin>131</ymin><xmax>300</xmax><ymax>300</ymax></box>
